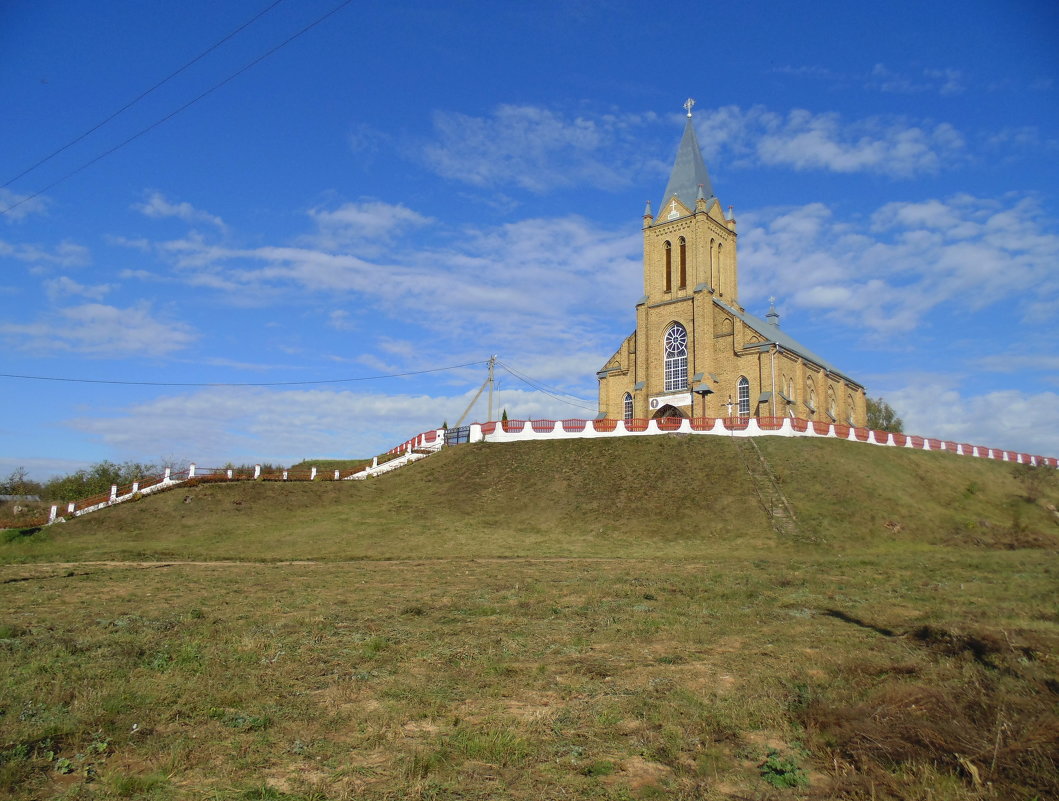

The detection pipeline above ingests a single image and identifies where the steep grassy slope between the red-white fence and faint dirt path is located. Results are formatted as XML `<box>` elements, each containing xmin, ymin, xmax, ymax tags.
<box><xmin>0</xmin><ymin>437</ymin><xmax>1057</xmax><ymax>562</ymax></box>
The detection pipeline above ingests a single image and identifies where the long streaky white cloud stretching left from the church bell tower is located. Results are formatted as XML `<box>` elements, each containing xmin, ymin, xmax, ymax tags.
<box><xmin>129</xmin><ymin>210</ymin><xmax>641</xmax><ymax>375</ymax></box>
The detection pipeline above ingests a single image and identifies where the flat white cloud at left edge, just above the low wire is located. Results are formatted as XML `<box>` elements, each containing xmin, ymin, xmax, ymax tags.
<box><xmin>0</xmin><ymin>303</ymin><xmax>197</xmax><ymax>357</ymax></box>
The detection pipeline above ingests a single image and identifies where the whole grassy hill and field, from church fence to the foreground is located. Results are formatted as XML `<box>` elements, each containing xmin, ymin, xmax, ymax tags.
<box><xmin>0</xmin><ymin>437</ymin><xmax>1059</xmax><ymax>801</ymax></box>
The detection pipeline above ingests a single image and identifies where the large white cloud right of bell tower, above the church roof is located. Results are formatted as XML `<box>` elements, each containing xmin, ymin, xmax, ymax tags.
<box><xmin>740</xmin><ymin>195</ymin><xmax>1059</xmax><ymax>334</ymax></box>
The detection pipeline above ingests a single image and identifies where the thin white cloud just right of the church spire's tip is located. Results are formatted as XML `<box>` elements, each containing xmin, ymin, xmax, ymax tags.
<box><xmin>696</xmin><ymin>106</ymin><xmax>966</xmax><ymax>178</ymax></box>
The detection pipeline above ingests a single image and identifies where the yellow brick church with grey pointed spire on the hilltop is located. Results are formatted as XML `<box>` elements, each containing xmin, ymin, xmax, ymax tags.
<box><xmin>596</xmin><ymin>100</ymin><xmax>867</xmax><ymax>426</ymax></box>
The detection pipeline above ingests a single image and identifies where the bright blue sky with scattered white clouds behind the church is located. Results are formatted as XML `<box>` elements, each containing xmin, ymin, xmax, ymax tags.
<box><xmin>0</xmin><ymin>0</ymin><xmax>1059</xmax><ymax>478</ymax></box>
